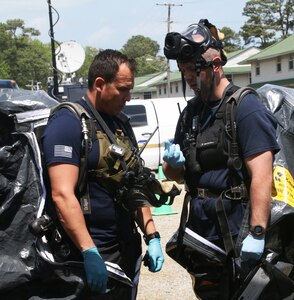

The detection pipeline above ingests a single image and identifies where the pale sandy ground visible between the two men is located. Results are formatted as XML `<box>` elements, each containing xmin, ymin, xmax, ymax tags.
<box><xmin>137</xmin><ymin>186</ymin><xmax>197</xmax><ymax>300</ymax></box>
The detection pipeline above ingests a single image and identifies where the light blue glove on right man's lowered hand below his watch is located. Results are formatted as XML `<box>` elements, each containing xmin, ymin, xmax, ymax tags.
<box><xmin>240</xmin><ymin>234</ymin><xmax>264</xmax><ymax>262</ymax></box>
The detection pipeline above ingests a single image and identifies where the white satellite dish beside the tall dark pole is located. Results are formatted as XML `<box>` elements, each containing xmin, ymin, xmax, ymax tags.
<box><xmin>55</xmin><ymin>41</ymin><xmax>85</xmax><ymax>73</ymax></box>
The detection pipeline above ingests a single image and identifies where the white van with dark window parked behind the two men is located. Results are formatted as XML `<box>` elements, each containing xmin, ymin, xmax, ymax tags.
<box><xmin>123</xmin><ymin>97</ymin><xmax>187</xmax><ymax>170</ymax></box>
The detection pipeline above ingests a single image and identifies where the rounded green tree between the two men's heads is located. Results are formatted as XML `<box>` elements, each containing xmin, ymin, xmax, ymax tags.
<box><xmin>121</xmin><ymin>35</ymin><xmax>167</xmax><ymax>76</ymax></box>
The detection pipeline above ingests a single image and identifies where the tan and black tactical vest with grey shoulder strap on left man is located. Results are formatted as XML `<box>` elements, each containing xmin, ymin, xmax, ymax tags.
<box><xmin>51</xmin><ymin>102</ymin><xmax>142</xmax><ymax>209</ymax></box>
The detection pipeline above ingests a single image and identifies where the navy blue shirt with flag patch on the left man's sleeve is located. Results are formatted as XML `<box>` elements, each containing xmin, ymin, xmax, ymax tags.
<box><xmin>42</xmin><ymin>100</ymin><xmax>133</xmax><ymax>248</ymax></box>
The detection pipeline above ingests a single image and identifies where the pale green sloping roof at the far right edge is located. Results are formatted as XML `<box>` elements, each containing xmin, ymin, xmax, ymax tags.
<box><xmin>242</xmin><ymin>34</ymin><xmax>294</xmax><ymax>63</ymax></box>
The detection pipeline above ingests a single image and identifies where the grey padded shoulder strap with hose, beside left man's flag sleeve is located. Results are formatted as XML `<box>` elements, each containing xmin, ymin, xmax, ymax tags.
<box><xmin>50</xmin><ymin>102</ymin><xmax>93</xmax><ymax>214</ymax></box>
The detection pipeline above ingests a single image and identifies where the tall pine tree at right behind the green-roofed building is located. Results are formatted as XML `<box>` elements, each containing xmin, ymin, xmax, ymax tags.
<box><xmin>240</xmin><ymin>0</ymin><xmax>294</xmax><ymax>48</ymax></box>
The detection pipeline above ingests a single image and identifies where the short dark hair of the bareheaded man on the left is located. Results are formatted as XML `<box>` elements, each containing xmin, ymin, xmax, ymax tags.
<box><xmin>88</xmin><ymin>49</ymin><xmax>136</xmax><ymax>90</ymax></box>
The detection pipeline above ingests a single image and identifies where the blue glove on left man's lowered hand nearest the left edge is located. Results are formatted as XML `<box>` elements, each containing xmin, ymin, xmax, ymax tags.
<box><xmin>82</xmin><ymin>247</ymin><xmax>108</xmax><ymax>294</ymax></box>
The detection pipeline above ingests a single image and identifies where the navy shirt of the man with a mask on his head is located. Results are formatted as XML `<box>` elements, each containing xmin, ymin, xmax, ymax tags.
<box><xmin>174</xmin><ymin>94</ymin><xmax>279</xmax><ymax>240</ymax></box>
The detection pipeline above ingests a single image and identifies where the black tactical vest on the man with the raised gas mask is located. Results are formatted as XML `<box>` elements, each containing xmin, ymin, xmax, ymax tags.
<box><xmin>180</xmin><ymin>85</ymin><xmax>255</xmax><ymax>192</ymax></box>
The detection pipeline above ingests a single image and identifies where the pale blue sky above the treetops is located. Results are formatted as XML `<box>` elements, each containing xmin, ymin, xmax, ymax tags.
<box><xmin>0</xmin><ymin>0</ymin><xmax>248</xmax><ymax>68</ymax></box>
